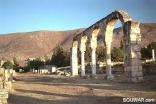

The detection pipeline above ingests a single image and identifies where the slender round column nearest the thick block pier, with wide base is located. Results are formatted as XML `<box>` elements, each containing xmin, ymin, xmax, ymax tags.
<box><xmin>106</xmin><ymin>43</ymin><xmax>114</xmax><ymax>80</ymax></box>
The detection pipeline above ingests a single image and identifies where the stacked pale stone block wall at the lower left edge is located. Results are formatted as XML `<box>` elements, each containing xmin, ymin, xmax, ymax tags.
<box><xmin>0</xmin><ymin>68</ymin><xmax>15</xmax><ymax>104</ymax></box>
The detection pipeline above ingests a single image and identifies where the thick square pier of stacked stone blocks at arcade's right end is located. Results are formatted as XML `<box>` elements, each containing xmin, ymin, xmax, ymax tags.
<box><xmin>123</xmin><ymin>21</ymin><xmax>143</xmax><ymax>82</ymax></box>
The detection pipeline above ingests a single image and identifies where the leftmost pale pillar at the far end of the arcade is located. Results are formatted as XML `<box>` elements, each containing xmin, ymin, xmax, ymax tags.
<box><xmin>70</xmin><ymin>47</ymin><xmax>78</xmax><ymax>76</ymax></box>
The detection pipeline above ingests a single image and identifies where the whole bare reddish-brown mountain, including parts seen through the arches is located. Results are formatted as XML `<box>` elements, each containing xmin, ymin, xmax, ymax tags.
<box><xmin>0</xmin><ymin>23</ymin><xmax>156</xmax><ymax>65</ymax></box>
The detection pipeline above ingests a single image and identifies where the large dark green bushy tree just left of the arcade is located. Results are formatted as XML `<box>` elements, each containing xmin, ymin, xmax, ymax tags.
<box><xmin>51</xmin><ymin>45</ymin><xmax>70</xmax><ymax>67</ymax></box>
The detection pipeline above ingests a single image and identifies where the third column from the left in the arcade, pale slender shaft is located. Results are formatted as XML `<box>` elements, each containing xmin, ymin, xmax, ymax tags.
<box><xmin>92</xmin><ymin>47</ymin><xmax>96</xmax><ymax>75</ymax></box>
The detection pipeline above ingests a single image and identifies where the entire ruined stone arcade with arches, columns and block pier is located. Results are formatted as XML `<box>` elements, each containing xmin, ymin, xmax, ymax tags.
<box><xmin>70</xmin><ymin>10</ymin><xmax>143</xmax><ymax>82</ymax></box>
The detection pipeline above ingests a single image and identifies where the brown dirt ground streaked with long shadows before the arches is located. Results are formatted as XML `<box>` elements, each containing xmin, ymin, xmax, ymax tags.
<box><xmin>8</xmin><ymin>73</ymin><xmax>156</xmax><ymax>104</ymax></box>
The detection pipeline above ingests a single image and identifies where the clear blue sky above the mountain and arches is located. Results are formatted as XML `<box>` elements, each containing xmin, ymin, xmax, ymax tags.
<box><xmin>0</xmin><ymin>0</ymin><xmax>156</xmax><ymax>34</ymax></box>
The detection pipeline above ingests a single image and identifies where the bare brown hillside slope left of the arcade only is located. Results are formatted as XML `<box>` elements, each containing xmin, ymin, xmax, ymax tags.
<box><xmin>0</xmin><ymin>29</ymin><xmax>84</xmax><ymax>64</ymax></box>
